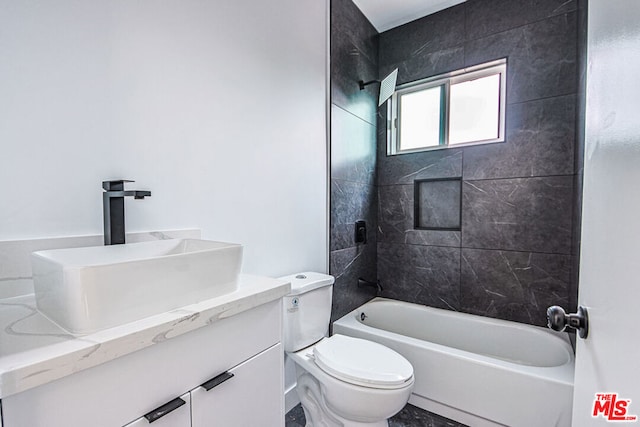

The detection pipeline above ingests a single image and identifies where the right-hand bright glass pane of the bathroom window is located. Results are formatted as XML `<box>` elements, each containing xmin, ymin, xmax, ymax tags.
<box><xmin>449</xmin><ymin>74</ymin><xmax>500</xmax><ymax>144</ymax></box>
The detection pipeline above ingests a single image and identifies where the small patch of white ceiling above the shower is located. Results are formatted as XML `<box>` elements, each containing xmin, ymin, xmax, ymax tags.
<box><xmin>353</xmin><ymin>0</ymin><xmax>466</xmax><ymax>33</ymax></box>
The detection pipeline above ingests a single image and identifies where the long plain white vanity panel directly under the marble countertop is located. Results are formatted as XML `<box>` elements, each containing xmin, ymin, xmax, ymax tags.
<box><xmin>2</xmin><ymin>299</ymin><xmax>282</xmax><ymax>427</ymax></box>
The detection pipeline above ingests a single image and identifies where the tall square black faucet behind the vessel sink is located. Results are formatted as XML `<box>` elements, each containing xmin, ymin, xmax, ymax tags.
<box><xmin>102</xmin><ymin>179</ymin><xmax>151</xmax><ymax>245</ymax></box>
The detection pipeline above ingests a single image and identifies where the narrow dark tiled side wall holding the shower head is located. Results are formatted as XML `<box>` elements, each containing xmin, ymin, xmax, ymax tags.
<box><xmin>329</xmin><ymin>0</ymin><xmax>378</xmax><ymax>321</ymax></box>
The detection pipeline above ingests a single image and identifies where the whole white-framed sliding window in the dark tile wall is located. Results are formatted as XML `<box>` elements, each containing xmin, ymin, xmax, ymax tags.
<box><xmin>387</xmin><ymin>59</ymin><xmax>507</xmax><ymax>155</ymax></box>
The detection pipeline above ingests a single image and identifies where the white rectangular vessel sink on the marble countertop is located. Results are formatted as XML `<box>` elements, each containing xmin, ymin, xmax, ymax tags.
<box><xmin>31</xmin><ymin>239</ymin><xmax>242</xmax><ymax>334</ymax></box>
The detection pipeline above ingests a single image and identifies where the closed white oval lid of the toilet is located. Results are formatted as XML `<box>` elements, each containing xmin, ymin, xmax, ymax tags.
<box><xmin>313</xmin><ymin>334</ymin><xmax>413</xmax><ymax>389</ymax></box>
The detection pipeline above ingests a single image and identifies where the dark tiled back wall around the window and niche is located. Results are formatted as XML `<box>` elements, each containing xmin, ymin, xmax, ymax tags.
<box><xmin>377</xmin><ymin>0</ymin><xmax>583</xmax><ymax>325</ymax></box>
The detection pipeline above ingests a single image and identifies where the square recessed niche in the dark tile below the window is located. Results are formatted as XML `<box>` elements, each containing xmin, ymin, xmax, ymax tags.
<box><xmin>413</xmin><ymin>178</ymin><xmax>462</xmax><ymax>230</ymax></box>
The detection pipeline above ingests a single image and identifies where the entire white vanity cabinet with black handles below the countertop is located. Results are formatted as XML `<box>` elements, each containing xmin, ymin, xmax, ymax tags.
<box><xmin>2</xmin><ymin>299</ymin><xmax>284</xmax><ymax>427</ymax></box>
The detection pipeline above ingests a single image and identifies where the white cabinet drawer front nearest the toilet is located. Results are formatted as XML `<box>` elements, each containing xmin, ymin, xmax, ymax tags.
<box><xmin>191</xmin><ymin>344</ymin><xmax>284</xmax><ymax>427</ymax></box>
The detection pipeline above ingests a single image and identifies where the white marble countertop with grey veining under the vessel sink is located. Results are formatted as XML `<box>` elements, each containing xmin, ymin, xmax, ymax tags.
<box><xmin>0</xmin><ymin>274</ymin><xmax>290</xmax><ymax>398</ymax></box>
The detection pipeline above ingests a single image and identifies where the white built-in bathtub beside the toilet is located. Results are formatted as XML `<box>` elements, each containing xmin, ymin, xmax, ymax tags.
<box><xmin>333</xmin><ymin>298</ymin><xmax>574</xmax><ymax>427</ymax></box>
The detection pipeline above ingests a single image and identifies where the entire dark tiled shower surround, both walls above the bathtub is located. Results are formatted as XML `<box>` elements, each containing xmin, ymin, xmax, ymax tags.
<box><xmin>330</xmin><ymin>0</ymin><xmax>582</xmax><ymax>325</ymax></box>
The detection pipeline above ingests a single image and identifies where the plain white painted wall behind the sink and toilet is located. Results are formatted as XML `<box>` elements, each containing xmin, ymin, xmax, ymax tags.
<box><xmin>0</xmin><ymin>0</ymin><xmax>328</xmax><ymax>276</ymax></box>
